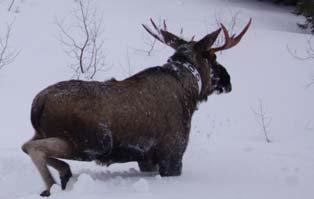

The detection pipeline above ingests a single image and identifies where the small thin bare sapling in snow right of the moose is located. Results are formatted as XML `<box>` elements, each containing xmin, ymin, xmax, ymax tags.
<box><xmin>251</xmin><ymin>100</ymin><xmax>272</xmax><ymax>143</ymax></box>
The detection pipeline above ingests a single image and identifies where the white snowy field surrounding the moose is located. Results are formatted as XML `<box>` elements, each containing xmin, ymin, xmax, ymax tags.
<box><xmin>0</xmin><ymin>0</ymin><xmax>314</xmax><ymax>199</ymax></box>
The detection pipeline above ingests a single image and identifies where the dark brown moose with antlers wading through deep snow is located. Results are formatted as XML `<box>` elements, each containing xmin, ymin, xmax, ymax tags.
<box><xmin>22</xmin><ymin>19</ymin><xmax>251</xmax><ymax>196</ymax></box>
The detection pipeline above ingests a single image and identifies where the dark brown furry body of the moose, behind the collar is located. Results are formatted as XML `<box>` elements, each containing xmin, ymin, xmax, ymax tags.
<box><xmin>31</xmin><ymin>67</ymin><xmax>198</xmax><ymax>162</ymax></box>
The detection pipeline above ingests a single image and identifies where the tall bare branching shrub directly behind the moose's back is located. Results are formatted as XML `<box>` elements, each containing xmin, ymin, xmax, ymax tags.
<box><xmin>57</xmin><ymin>0</ymin><xmax>105</xmax><ymax>79</ymax></box>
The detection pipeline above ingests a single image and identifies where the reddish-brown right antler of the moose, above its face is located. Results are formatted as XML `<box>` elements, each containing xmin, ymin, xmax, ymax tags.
<box><xmin>210</xmin><ymin>18</ymin><xmax>252</xmax><ymax>53</ymax></box>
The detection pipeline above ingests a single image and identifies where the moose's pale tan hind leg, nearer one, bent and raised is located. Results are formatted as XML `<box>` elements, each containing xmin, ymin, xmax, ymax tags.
<box><xmin>22</xmin><ymin>138</ymin><xmax>73</xmax><ymax>196</ymax></box>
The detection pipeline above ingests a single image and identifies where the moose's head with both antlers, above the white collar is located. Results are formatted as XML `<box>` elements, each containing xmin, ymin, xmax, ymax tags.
<box><xmin>143</xmin><ymin>19</ymin><xmax>252</xmax><ymax>100</ymax></box>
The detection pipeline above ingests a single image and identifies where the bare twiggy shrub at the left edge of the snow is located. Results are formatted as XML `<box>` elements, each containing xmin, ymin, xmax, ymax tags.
<box><xmin>0</xmin><ymin>22</ymin><xmax>19</xmax><ymax>69</ymax></box>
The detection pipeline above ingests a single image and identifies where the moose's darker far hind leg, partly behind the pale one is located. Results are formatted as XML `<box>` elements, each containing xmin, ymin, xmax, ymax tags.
<box><xmin>47</xmin><ymin>158</ymin><xmax>72</xmax><ymax>190</ymax></box>
